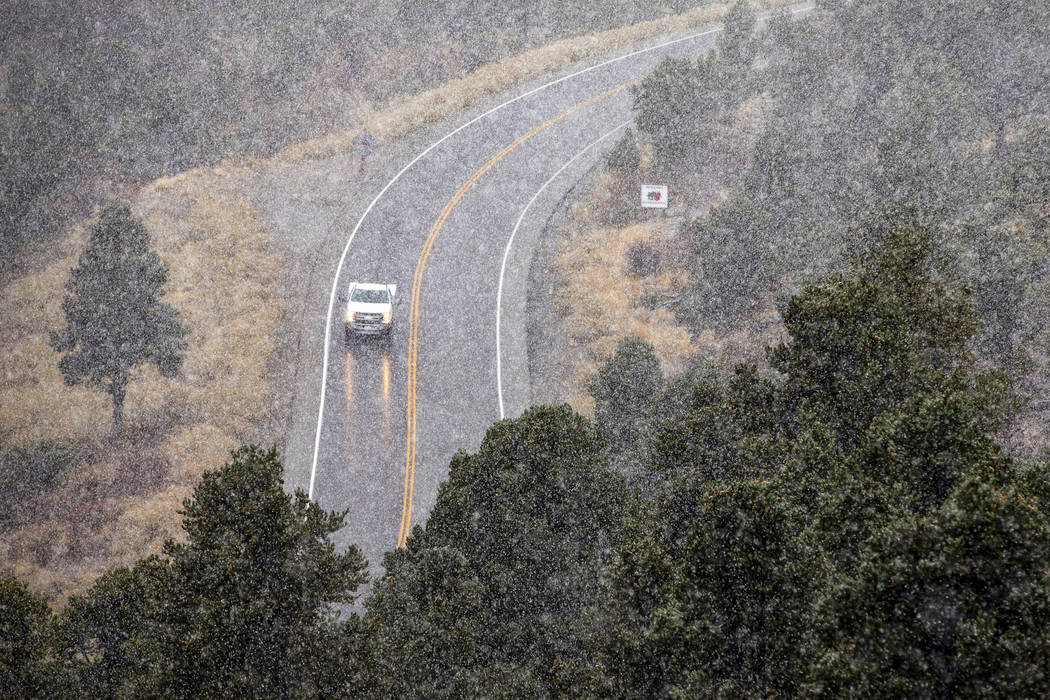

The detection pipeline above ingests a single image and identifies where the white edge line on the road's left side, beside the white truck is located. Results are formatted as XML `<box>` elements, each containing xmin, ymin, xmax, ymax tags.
<box><xmin>307</xmin><ymin>2</ymin><xmax>810</xmax><ymax>500</ymax></box>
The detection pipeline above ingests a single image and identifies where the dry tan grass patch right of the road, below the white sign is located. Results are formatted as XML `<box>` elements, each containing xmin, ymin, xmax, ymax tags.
<box><xmin>555</xmin><ymin>128</ymin><xmax>783</xmax><ymax>415</ymax></box>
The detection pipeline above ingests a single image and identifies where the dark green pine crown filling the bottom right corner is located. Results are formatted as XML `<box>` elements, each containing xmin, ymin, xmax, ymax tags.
<box><xmin>807</xmin><ymin>478</ymin><xmax>1050</xmax><ymax>698</ymax></box>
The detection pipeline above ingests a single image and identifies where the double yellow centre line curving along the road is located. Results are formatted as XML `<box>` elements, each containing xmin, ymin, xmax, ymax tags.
<box><xmin>397</xmin><ymin>81</ymin><xmax>638</xmax><ymax>547</ymax></box>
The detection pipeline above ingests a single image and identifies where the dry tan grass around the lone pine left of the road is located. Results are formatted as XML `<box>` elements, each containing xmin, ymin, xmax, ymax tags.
<box><xmin>0</xmin><ymin>168</ymin><xmax>282</xmax><ymax>601</ymax></box>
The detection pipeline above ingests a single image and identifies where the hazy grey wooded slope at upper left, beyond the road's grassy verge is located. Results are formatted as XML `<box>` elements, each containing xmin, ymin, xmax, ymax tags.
<box><xmin>0</xmin><ymin>0</ymin><xmax>789</xmax><ymax>274</ymax></box>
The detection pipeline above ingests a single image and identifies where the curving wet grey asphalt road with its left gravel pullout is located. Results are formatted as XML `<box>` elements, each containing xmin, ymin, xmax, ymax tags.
<box><xmin>249</xmin><ymin>8</ymin><xmax>806</xmax><ymax>575</ymax></box>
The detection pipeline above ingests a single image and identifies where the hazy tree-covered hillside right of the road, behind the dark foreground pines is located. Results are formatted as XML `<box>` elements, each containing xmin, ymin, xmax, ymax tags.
<box><xmin>567</xmin><ymin>2</ymin><xmax>1050</xmax><ymax>453</ymax></box>
